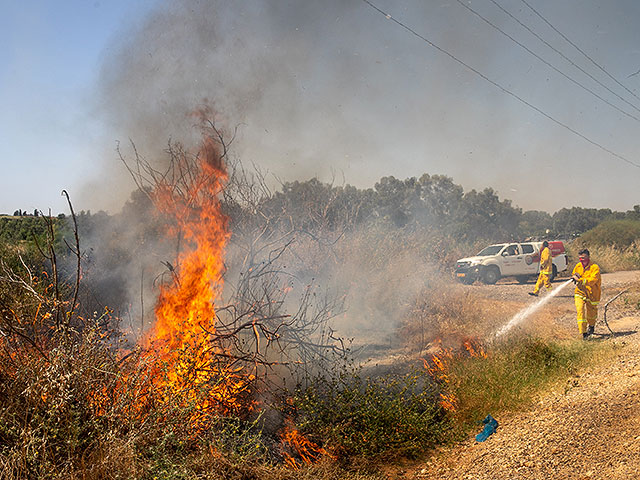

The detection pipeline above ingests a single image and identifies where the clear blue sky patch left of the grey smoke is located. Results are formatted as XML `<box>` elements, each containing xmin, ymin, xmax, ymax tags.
<box><xmin>0</xmin><ymin>0</ymin><xmax>160</xmax><ymax>213</ymax></box>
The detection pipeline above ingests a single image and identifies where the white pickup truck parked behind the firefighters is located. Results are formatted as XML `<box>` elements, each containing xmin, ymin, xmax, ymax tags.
<box><xmin>455</xmin><ymin>241</ymin><xmax>569</xmax><ymax>285</ymax></box>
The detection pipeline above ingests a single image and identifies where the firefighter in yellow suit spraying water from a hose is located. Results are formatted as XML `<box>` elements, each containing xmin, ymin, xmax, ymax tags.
<box><xmin>571</xmin><ymin>248</ymin><xmax>602</xmax><ymax>339</ymax></box>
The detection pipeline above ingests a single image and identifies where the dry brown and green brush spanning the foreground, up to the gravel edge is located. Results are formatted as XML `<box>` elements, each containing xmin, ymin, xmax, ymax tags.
<box><xmin>0</xmin><ymin>216</ymin><xmax>601</xmax><ymax>480</ymax></box>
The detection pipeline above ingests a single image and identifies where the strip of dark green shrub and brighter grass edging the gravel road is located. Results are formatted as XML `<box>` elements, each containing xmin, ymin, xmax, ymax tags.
<box><xmin>294</xmin><ymin>338</ymin><xmax>596</xmax><ymax>460</ymax></box>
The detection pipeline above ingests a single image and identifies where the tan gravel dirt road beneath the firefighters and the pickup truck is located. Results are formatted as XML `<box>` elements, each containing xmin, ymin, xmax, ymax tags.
<box><xmin>410</xmin><ymin>272</ymin><xmax>640</xmax><ymax>480</ymax></box>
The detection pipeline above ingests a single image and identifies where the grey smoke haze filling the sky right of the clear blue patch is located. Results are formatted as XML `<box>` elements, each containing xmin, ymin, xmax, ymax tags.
<box><xmin>85</xmin><ymin>0</ymin><xmax>637</xmax><ymax>212</ymax></box>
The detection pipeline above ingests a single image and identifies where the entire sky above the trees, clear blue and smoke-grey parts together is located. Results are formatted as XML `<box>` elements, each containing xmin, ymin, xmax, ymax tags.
<box><xmin>0</xmin><ymin>0</ymin><xmax>640</xmax><ymax>213</ymax></box>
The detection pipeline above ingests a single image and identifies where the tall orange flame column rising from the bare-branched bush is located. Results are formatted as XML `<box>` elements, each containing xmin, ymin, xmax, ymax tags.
<box><xmin>145</xmin><ymin>133</ymin><xmax>253</xmax><ymax>422</ymax></box>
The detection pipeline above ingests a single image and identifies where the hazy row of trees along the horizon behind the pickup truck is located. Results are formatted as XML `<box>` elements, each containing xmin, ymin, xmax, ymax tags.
<box><xmin>0</xmin><ymin>173</ymin><xmax>640</xmax><ymax>243</ymax></box>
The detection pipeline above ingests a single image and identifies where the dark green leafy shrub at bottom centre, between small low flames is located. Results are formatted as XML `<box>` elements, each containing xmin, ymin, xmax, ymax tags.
<box><xmin>294</xmin><ymin>368</ymin><xmax>447</xmax><ymax>460</ymax></box>
